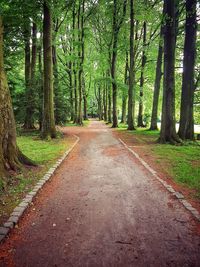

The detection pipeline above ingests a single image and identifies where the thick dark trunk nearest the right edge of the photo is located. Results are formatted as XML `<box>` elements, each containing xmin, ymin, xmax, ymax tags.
<box><xmin>178</xmin><ymin>0</ymin><xmax>197</xmax><ymax>140</ymax></box>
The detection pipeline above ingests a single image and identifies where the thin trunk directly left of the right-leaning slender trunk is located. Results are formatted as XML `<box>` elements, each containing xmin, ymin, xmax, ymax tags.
<box><xmin>138</xmin><ymin>21</ymin><xmax>147</xmax><ymax>127</ymax></box>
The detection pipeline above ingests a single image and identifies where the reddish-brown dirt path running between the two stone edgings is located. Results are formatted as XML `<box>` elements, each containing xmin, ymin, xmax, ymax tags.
<box><xmin>0</xmin><ymin>121</ymin><xmax>200</xmax><ymax>267</ymax></box>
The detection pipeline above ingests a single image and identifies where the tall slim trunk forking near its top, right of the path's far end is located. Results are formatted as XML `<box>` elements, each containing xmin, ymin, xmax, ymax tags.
<box><xmin>111</xmin><ymin>0</ymin><xmax>127</xmax><ymax>128</ymax></box>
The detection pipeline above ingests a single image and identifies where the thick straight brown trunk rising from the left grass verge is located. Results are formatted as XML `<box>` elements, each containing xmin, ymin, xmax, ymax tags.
<box><xmin>42</xmin><ymin>1</ymin><xmax>56</xmax><ymax>139</ymax></box>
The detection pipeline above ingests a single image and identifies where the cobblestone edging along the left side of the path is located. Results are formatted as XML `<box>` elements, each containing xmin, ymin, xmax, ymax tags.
<box><xmin>0</xmin><ymin>135</ymin><xmax>80</xmax><ymax>242</ymax></box>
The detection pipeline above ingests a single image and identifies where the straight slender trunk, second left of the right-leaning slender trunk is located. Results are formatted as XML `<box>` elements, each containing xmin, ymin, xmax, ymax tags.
<box><xmin>128</xmin><ymin>0</ymin><xmax>135</xmax><ymax>130</ymax></box>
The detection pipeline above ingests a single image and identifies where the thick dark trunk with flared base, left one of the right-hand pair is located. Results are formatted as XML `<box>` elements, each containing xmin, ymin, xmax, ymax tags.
<box><xmin>159</xmin><ymin>0</ymin><xmax>180</xmax><ymax>144</ymax></box>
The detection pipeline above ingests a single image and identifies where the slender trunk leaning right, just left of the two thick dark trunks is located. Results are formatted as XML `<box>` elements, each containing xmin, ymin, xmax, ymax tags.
<box><xmin>150</xmin><ymin>21</ymin><xmax>163</xmax><ymax>130</ymax></box>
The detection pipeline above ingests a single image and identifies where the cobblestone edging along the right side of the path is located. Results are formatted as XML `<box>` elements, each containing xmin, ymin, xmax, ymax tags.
<box><xmin>119</xmin><ymin>138</ymin><xmax>200</xmax><ymax>222</ymax></box>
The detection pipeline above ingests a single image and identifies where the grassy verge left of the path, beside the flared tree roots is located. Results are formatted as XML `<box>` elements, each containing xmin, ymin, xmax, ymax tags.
<box><xmin>0</xmin><ymin>131</ymin><xmax>69</xmax><ymax>224</ymax></box>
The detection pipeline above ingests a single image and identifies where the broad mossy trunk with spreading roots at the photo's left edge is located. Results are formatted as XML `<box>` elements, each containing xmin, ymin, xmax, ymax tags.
<box><xmin>0</xmin><ymin>16</ymin><xmax>33</xmax><ymax>179</ymax></box>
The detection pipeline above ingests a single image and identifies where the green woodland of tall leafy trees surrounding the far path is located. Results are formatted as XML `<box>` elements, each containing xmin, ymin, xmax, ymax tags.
<box><xmin>0</xmin><ymin>0</ymin><xmax>200</xmax><ymax>180</ymax></box>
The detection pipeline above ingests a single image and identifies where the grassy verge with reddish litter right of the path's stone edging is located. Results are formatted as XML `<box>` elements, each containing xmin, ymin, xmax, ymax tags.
<box><xmin>118</xmin><ymin>125</ymin><xmax>200</xmax><ymax>198</ymax></box>
